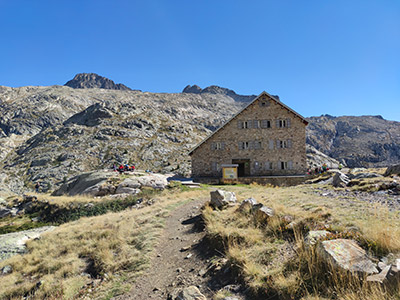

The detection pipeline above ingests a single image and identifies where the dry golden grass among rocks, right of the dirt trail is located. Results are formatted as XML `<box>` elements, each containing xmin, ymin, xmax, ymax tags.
<box><xmin>204</xmin><ymin>185</ymin><xmax>400</xmax><ymax>300</ymax></box>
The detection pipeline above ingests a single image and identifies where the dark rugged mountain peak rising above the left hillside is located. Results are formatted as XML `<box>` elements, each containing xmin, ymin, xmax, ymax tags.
<box><xmin>64</xmin><ymin>73</ymin><xmax>131</xmax><ymax>91</ymax></box>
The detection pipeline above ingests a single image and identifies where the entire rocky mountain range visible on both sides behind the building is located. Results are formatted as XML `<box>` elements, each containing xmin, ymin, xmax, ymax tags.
<box><xmin>0</xmin><ymin>73</ymin><xmax>400</xmax><ymax>192</ymax></box>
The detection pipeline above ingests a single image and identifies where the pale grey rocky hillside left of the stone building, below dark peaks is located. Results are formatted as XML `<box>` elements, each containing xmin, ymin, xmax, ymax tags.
<box><xmin>0</xmin><ymin>82</ymin><xmax>242</xmax><ymax>192</ymax></box>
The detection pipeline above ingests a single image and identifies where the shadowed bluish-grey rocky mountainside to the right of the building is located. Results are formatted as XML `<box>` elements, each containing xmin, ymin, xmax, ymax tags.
<box><xmin>307</xmin><ymin>115</ymin><xmax>400</xmax><ymax>167</ymax></box>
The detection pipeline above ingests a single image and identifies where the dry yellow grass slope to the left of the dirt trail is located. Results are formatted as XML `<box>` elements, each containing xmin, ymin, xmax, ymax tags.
<box><xmin>0</xmin><ymin>186</ymin><xmax>208</xmax><ymax>299</ymax></box>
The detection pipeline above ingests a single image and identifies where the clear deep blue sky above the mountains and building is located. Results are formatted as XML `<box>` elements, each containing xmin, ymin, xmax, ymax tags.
<box><xmin>0</xmin><ymin>0</ymin><xmax>400</xmax><ymax>121</ymax></box>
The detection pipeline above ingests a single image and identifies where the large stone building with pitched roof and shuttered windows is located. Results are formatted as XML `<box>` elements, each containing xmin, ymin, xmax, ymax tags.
<box><xmin>189</xmin><ymin>92</ymin><xmax>308</xmax><ymax>179</ymax></box>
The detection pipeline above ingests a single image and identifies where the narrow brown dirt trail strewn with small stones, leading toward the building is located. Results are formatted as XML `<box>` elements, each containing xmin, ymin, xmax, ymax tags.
<box><xmin>114</xmin><ymin>199</ymin><xmax>217</xmax><ymax>300</ymax></box>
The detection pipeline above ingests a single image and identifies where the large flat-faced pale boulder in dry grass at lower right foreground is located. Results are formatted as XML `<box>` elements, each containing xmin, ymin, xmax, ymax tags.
<box><xmin>318</xmin><ymin>239</ymin><xmax>378</xmax><ymax>274</ymax></box>
